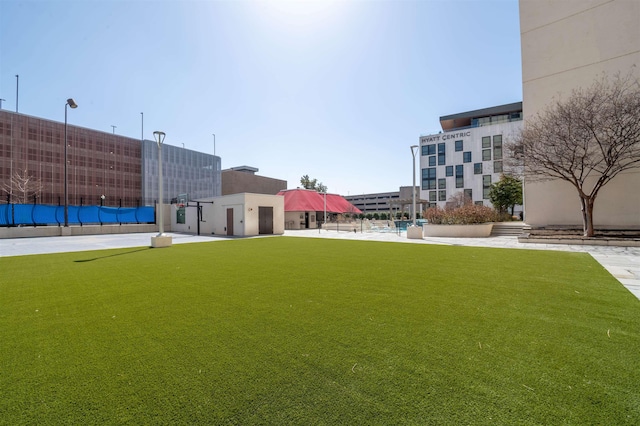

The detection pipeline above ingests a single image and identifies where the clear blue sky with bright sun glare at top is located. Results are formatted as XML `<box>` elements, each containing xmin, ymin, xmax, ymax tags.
<box><xmin>0</xmin><ymin>0</ymin><xmax>522</xmax><ymax>195</ymax></box>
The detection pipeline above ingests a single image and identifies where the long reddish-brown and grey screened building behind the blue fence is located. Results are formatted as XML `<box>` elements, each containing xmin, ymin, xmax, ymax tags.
<box><xmin>0</xmin><ymin>110</ymin><xmax>221</xmax><ymax>206</ymax></box>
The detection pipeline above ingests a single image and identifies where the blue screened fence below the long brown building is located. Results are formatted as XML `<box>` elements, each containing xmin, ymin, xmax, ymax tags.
<box><xmin>0</xmin><ymin>204</ymin><xmax>156</xmax><ymax>227</ymax></box>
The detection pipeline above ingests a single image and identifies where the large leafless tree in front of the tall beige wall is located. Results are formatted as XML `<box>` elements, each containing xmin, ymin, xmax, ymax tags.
<box><xmin>507</xmin><ymin>73</ymin><xmax>640</xmax><ymax>237</ymax></box>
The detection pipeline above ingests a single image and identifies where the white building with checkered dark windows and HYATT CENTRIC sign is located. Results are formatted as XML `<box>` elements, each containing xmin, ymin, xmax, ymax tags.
<box><xmin>420</xmin><ymin>102</ymin><xmax>522</xmax><ymax>211</ymax></box>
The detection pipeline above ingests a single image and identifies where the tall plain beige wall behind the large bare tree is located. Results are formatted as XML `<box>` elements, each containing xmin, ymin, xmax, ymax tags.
<box><xmin>520</xmin><ymin>0</ymin><xmax>640</xmax><ymax>229</ymax></box>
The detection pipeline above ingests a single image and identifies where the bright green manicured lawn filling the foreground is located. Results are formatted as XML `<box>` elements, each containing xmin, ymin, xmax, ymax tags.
<box><xmin>0</xmin><ymin>237</ymin><xmax>640</xmax><ymax>425</ymax></box>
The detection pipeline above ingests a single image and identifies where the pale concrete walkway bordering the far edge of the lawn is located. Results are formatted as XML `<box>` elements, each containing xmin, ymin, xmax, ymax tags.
<box><xmin>0</xmin><ymin>229</ymin><xmax>640</xmax><ymax>299</ymax></box>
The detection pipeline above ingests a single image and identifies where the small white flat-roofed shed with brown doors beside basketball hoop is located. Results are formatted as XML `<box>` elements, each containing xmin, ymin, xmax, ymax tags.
<box><xmin>171</xmin><ymin>192</ymin><xmax>284</xmax><ymax>237</ymax></box>
